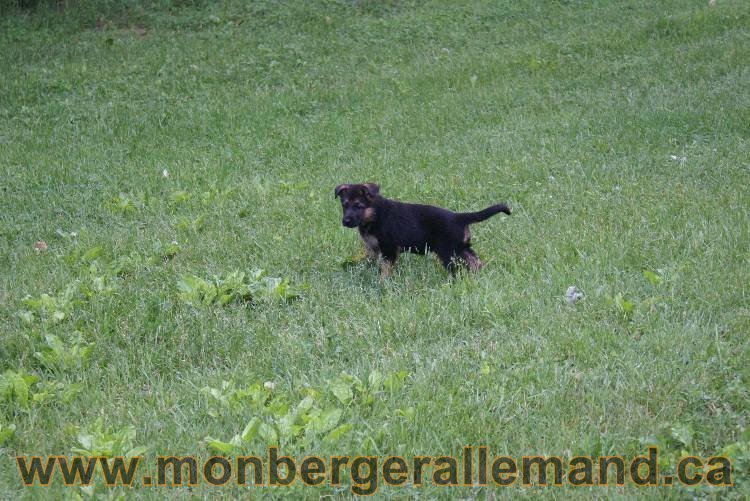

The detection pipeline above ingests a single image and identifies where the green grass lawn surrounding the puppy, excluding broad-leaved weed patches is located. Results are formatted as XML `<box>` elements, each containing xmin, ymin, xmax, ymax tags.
<box><xmin>0</xmin><ymin>0</ymin><xmax>750</xmax><ymax>499</ymax></box>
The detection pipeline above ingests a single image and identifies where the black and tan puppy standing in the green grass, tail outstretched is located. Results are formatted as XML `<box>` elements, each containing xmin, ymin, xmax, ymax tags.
<box><xmin>334</xmin><ymin>183</ymin><xmax>510</xmax><ymax>275</ymax></box>
